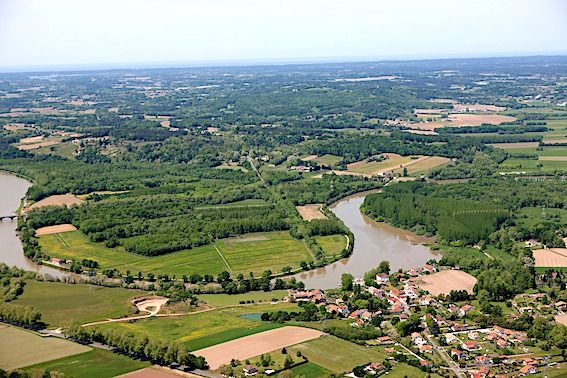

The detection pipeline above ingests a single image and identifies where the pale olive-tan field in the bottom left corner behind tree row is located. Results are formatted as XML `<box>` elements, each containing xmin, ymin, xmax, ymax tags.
<box><xmin>0</xmin><ymin>323</ymin><xmax>90</xmax><ymax>370</ymax></box>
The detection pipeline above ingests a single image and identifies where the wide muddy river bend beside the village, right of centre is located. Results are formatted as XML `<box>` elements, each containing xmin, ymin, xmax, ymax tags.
<box><xmin>296</xmin><ymin>193</ymin><xmax>441</xmax><ymax>289</ymax></box>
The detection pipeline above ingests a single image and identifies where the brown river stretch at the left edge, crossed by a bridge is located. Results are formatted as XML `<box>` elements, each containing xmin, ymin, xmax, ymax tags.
<box><xmin>0</xmin><ymin>171</ymin><xmax>64</xmax><ymax>277</ymax></box>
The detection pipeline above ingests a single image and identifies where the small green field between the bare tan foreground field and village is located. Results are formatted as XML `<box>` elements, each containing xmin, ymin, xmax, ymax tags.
<box><xmin>287</xmin><ymin>336</ymin><xmax>386</xmax><ymax>373</ymax></box>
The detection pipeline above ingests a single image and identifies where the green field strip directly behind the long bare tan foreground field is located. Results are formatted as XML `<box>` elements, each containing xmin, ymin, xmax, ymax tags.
<box><xmin>99</xmin><ymin>303</ymin><xmax>297</xmax><ymax>350</ymax></box>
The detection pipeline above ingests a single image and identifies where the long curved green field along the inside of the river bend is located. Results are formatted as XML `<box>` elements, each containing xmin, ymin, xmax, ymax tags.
<box><xmin>39</xmin><ymin>231</ymin><xmax>310</xmax><ymax>277</ymax></box>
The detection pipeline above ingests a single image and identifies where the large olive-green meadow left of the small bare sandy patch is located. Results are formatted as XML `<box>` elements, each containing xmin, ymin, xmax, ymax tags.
<box><xmin>14</xmin><ymin>281</ymin><xmax>138</xmax><ymax>326</ymax></box>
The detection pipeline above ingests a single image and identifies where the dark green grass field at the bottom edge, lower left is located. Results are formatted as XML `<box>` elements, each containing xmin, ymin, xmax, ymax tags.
<box><xmin>26</xmin><ymin>349</ymin><xmax>151</xmax><ymax>378</ymax></box>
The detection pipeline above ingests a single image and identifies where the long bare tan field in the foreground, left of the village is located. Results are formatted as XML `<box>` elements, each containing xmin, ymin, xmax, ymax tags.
<box><xmin>193</xmin><ymin>326</ymin><xmax>323</xmax><ymax>370</ymax></box>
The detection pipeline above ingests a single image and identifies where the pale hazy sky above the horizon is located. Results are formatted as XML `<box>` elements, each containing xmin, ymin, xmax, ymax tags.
<box><xmin>0</xmin><ymin>0</ymin><xmax>567</xmax><ymax>71</ymax></box>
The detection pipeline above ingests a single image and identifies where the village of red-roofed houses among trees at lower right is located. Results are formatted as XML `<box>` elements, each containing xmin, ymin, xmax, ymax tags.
<box><xmin>287</xmin><ymin>264</ymin><xmax>566</xmax><ymax>378</ymax></box>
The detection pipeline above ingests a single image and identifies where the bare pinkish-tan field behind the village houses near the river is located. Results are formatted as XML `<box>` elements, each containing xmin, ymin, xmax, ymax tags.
<box><xmin>417</xmin><ymin>269</ymin><xmax>476</xmax><ymax>295</ymax></box>
